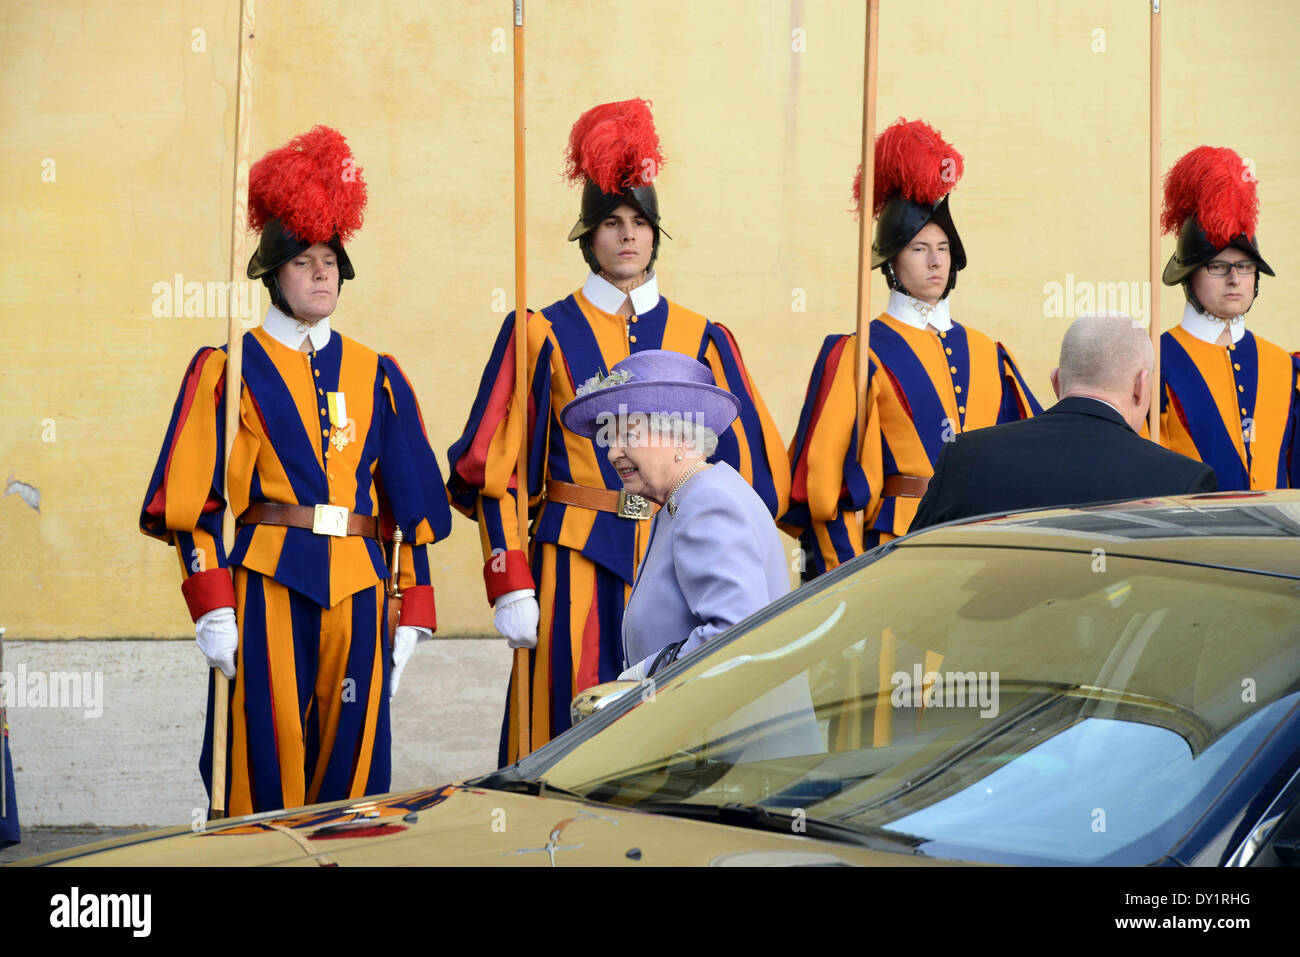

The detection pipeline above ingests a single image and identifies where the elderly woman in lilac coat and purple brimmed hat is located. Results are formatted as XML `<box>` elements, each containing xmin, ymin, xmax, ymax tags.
<box><xmin>560</xmin><ymin>350</ymin><xmax>790</xmax><ymax>680</ymax></box>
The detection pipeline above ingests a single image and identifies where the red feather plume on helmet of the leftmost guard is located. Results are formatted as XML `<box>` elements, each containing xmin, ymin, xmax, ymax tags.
<box><xmin>248</xmin><ymin>126</ymin><xmax>365</xmax><ymax>243</ymax></box>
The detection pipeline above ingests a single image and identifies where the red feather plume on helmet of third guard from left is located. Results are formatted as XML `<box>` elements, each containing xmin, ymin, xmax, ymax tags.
<box><xmin>853</xmin><ymin>117</ymin><xmax>966</xmax><ymax>216</ymax></box>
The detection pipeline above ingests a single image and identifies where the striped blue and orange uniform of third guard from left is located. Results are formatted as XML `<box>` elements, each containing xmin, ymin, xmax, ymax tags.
<box><xmin>781</xmin><ymin>312</ymin><xmax>1043</xmax><ymax>579</ymax></box>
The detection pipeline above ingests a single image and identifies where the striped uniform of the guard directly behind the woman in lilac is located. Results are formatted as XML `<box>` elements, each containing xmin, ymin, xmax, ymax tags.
<box><xmin>449</xmin><ymin>283</ymin><xmax>789</xmax><ymax>765</ymax></box>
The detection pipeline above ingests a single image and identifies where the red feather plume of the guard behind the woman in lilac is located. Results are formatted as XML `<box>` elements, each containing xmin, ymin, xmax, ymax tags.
<box><xmin>564</xmin><ymin>99</ymin><xmax>663</xmax><ymax>192</ymax></box>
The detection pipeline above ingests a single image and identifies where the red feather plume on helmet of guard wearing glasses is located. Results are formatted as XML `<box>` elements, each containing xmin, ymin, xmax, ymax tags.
<box><xmin>1160</xmin><ymin>146</ymin><xmax>1260</xmax><ymax>247</ymax></box>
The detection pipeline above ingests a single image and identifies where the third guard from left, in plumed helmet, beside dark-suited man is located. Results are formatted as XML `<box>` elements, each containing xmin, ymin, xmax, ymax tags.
<box><xmin>781</xmin><ymin>118</ymin><xmax>1043</xmax><ymax>580</ymax></box>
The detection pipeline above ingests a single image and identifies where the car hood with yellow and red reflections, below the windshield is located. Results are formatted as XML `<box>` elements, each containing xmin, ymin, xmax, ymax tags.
<box><xmin>12</xmin><ymin>784</ymin><xmax>977</xmax><ymax>867</ymax></box>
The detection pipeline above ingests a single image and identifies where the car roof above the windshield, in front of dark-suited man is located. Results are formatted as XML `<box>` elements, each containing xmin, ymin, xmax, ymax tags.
<box><xmin>896</xmin><ymin>489</ymin><xmax>1300</xmax><ymax>580</ymax></box>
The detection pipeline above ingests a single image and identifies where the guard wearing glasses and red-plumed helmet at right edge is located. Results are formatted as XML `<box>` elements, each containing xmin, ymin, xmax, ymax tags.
<box><xmin>1160</xmin><ymin>146</ymin><xmax>1300</xmax><ymax>492</ymax></box>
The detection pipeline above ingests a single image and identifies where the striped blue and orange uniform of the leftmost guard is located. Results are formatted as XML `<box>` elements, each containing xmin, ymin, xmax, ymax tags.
<box><xmin>140</xmin><ymin>329</ymin><xmax>451</xmax><ymax>815</ymax></box>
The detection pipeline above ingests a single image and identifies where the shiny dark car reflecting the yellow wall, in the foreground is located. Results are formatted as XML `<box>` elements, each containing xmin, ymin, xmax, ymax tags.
<box><xmin>23</xmin><ymin>492</ymin><xmax>1300</xmax><ymax>867</ymax></box>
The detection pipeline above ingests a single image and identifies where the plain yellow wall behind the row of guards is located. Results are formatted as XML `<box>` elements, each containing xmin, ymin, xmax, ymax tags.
<box><xmin>0</xmin><ymin>0</ymin><xmax>1300</xmax><ymax>637</ymax></box>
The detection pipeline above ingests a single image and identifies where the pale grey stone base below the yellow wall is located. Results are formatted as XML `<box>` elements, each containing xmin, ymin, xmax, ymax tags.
<box><xmin>0</xmin><ymin>638</ymin><xmax>512</xmax><ymax>862</ymax></box>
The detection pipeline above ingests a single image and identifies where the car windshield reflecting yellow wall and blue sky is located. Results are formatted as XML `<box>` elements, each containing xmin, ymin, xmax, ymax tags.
<box><xmin>545</xmin><ymin>546</ymin><xmax>1300</xmax><ymax>865</ymax></box>
